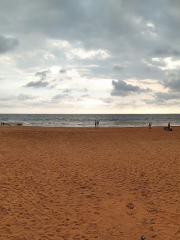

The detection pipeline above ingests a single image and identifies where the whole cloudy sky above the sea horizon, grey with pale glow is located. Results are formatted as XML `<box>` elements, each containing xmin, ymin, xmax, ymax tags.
<box><xmin>0</xmin><ymin>0</ymin><xmax>180</xmax><ymax>114</ymax></box>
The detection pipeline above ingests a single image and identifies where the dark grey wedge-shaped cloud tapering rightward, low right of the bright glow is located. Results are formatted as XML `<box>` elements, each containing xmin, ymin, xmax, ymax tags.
<box><xmin>111</xmin><ymin>80</ymin><xmax>151</xmax><ymax>97</ymax></box>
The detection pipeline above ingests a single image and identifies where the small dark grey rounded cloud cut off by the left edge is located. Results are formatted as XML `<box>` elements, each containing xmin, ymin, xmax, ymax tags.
<box><xmin>0</xmin><ymin>35</ymin><xmax>19</xmax><ymax>54</ymax></box>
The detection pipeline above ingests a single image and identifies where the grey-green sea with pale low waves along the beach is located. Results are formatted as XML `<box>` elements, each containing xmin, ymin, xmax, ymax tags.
<box><xmin>0</xmin><ymin>114</ymin><xmax>180</xmax><ymax>127</ymax></box>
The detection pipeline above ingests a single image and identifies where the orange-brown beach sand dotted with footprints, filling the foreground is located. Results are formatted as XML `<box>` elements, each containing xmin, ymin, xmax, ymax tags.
<box><xmin>0</xmin><ymin>126</ymin><xmax>180</xmax><ymax>240</ymax></box>
